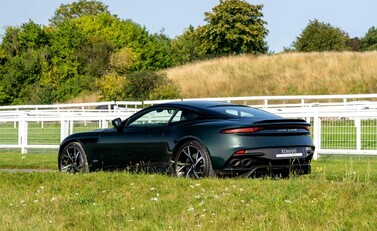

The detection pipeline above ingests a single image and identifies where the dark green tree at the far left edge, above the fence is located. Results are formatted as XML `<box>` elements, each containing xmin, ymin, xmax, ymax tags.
<box><xmin>0</xmin><ymin>20</ymin><xmax>49</xmax><ymax>104</ymax></box>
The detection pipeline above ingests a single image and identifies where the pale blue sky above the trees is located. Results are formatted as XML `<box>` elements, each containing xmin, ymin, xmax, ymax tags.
<box><xmin>0</xmin><ymin>0</ymin><xmax>377</xmax><ymax>52</ymax></box>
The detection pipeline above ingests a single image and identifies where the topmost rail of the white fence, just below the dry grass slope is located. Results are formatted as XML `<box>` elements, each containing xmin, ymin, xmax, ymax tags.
<box><xmin>0</xmin><ymin>94</ymin><xmax>377</xmax><ymax>112</ymax></box>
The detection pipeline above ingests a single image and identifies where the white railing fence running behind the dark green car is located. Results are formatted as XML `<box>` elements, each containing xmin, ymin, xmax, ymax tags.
<box><xmin>0</xmin><ymin>94</ymin><xmax>377</xmax><ymax>158</ymax></box>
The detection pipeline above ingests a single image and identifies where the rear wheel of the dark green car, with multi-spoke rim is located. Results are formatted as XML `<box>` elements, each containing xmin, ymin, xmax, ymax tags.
<box><xmin>174</xmin><ymin>140</ymin><xmax>215</xmax><ymax>179</ymax></box>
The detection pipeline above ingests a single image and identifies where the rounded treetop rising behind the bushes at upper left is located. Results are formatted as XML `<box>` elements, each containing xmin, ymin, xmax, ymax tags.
<box><xmin>50</xmin><ymin>0</ymin><xmax>110</xmax><ymax>26</ymax></box>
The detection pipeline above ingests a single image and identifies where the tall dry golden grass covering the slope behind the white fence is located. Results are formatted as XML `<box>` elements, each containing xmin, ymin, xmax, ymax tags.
<box><xmin>166</xmin><ymin>52</ymin><xmax>377</xmax><ymax>98</ymax></box>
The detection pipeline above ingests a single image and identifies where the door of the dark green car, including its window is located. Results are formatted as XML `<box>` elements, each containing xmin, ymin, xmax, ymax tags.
<box><xmin>93</xmin><ymin>108</ymin><xmax>177</xmax><ymax>166</ymax></box>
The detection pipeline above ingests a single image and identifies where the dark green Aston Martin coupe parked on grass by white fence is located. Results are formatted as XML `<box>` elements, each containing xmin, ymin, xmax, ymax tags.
<box><xmin>58</xmin><ymin>101</ymin><xmax>314</xmax><ymax>178</ymax></box>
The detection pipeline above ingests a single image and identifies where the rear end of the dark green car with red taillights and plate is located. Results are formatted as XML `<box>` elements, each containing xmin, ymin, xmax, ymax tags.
<box><xmin>220</xmin><ymin>118</ymin><xmax>314</xmax><ymax>177</ymax></box>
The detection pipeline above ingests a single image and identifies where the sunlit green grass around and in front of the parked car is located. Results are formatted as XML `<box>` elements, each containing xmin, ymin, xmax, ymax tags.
<box><xmin>0</xmin><ymin>153</ymin><xmax>377</xmax><ymax>230</ymax></box>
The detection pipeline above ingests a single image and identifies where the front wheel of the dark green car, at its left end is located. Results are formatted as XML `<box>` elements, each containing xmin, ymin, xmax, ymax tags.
<box><xmin>58</xmin><ymin>142</ymin><xmax>89</xmax><ymax>173</ymax></box>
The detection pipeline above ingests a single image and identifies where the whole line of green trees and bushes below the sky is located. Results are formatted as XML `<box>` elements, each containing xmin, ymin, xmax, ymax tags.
<box><xmin>0</xmin><ymin>0</ymin><xmax>377</xmax><ymax>105</ymax></box>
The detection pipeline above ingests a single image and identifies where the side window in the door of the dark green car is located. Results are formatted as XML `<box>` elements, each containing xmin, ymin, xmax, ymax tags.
<box><xmin>128</xmin><ymin>108</ymin><xmax>177</xmax><ymax>127</ymax></box>
